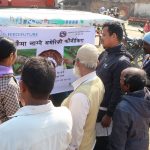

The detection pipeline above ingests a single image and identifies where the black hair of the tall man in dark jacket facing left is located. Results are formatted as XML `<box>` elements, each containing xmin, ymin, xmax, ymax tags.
<box><xmin>102</xmin><ymin>22</ymin><xmax>123</xmax><ymax>42</ymax></box>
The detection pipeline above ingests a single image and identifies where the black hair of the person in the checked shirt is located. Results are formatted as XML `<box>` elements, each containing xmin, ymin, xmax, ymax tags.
<box><xmin>0</xmin><ymin>37</ymin><xmax>16</xmax><ymax>61</ymax></box>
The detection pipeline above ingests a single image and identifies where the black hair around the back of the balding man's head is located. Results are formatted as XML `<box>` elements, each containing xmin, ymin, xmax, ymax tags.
<box><xmin>124</xmin><ymin>73</ymin><xmax>146</xmax><ymax>92</ymax></box>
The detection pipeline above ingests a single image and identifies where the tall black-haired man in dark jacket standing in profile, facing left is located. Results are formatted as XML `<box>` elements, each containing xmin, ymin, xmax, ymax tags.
<box><xmin>95</xmin><ymin>22</ymin><xmax>132</xmax><ymax>150</ymax></box>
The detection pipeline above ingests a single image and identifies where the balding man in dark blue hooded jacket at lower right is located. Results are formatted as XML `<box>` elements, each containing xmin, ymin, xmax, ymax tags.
<box><xmin>109</xmin><ymin>67</ymin><xmax>150</xmax><ymax>150</ymax></box>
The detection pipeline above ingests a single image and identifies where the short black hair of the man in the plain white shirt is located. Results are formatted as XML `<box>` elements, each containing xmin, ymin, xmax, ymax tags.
<box><xmin>21</xmin><ymin>57</ymin><xmax>56</xmax><ymax>99</ymax></box>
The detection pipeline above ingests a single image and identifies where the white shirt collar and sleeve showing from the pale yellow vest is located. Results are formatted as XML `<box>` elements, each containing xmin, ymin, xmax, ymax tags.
<box><xmin>69</xmin><ymin>72</ymin><xmax>97</xmax><ymax>150</ymax></box>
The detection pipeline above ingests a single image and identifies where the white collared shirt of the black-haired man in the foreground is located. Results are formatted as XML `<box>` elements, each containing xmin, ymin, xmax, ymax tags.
<box><xmin>0</xmin><ymin>102</ymin><xmax>72</xmax><ymax>150</ymax></box>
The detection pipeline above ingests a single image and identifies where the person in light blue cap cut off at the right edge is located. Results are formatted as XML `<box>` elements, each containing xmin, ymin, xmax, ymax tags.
<box><xmin>143</xmin><ymin>32</ymin><xmax>150</xmax><ymax>89</ymax></box>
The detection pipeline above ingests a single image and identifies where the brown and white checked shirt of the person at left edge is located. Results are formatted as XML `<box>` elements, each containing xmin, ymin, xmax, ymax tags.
<box><xmin>0</xmin><ymin>75</ymin><xmax>19</xmax><ymax>123</ymax></box>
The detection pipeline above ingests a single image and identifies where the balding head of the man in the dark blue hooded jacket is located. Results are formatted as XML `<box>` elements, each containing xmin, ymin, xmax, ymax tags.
<box><xmin>120</xmin><ymin>67</ymin><xmax>146</xmax><ymax>92</ymax></box>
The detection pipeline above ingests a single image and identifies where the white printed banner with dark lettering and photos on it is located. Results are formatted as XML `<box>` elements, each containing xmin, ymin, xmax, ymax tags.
<box><xmin>0</xmin><ymin>27</ymin><xmax>95</xmax><ymax>94</ymax></box>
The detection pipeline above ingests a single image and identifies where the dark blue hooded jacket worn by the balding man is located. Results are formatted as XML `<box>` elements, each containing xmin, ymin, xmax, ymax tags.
<box><xmin>109</xmin><ymin>90</ymin><xmax>150</xmax><ymax>150</ymax></box>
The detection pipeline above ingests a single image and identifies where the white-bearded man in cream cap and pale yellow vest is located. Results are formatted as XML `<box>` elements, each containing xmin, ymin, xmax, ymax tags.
<box><xmin>62</xmin><ymin>44</ymin><xmax>105</xmax><ymax>150</ymax></box>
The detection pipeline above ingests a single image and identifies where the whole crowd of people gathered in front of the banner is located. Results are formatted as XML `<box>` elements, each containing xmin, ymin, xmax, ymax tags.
<box><xmin>0</xmin><ymin>22</ymin><xmax>150</xmax><ymax>150</ymax></box>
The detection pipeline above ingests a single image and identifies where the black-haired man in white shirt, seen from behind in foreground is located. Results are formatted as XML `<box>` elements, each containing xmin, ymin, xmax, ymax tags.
<box><xmin>0</xmin><ymin>57</ymin><xmax>72</xmax><ymax>150</ymax></box>
